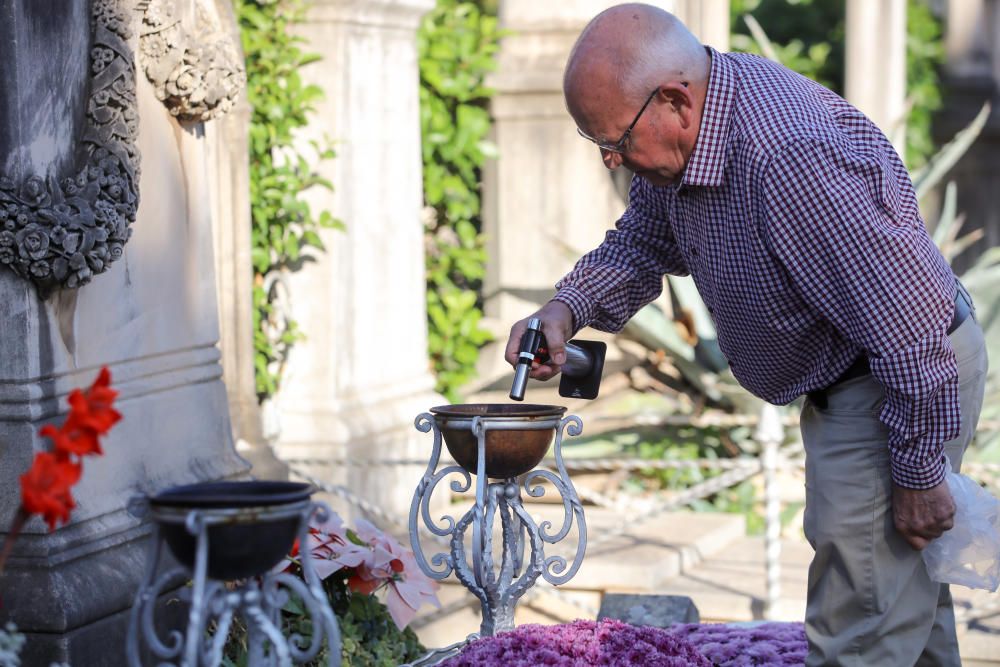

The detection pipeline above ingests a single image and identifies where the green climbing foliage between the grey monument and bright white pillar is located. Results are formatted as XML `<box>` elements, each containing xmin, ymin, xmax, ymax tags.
<box><xmin>234</xmin><ymin>0</ymin><xmax>341</xmax><ymax>400</ymax></box>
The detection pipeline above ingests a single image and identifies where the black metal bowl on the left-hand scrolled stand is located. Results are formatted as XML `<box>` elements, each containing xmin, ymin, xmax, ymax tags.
<box><xmin>150</xmin><ymin>481</ymin><xmax>315</xmax><ymax>581</ymax></box>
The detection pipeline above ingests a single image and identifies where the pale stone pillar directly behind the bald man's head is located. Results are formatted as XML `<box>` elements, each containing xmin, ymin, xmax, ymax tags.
<box><xmin>479</xmin><ymin>0</ymin><xmax>729</xmax><ymax>381</ymax></box>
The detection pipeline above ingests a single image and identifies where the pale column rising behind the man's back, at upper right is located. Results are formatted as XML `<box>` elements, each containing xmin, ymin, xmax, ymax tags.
<box><xmin>844</xmin><ymin>0</ymin><xmax>906</xmax><ymax>155</ymax></box>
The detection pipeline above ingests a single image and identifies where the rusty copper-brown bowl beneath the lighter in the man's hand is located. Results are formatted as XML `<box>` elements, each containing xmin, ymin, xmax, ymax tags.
<box><xmin>431</xmin><ymin>403</ymin><xmax>566</xmax><ymax>479</ymax></box>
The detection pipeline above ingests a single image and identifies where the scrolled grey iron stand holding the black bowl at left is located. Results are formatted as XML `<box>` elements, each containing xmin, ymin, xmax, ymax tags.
<box><xmin>127</xmin><ymin>500</ymin><xmax>340</xmax><ymax>667</ymax></box>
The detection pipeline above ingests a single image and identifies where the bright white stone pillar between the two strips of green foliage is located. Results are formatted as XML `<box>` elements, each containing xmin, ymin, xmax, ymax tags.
<box><xmin>275</xmin><ymin>0</ymin><xmax>444</xmax><ymax>528</ymax></box>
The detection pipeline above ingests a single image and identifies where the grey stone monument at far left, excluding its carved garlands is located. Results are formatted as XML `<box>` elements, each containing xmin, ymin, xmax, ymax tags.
<box><xmin>0</xmin><ymin>0</ymin><xmax>247</xmax><ymax>667</ymax></box>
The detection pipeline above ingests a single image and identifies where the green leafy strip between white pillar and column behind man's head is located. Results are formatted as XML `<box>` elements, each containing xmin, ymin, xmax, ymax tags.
<box><xmin>417</xmin><ymin>0</ymin><xmax>501</xmax><ymax>403</ymax></box>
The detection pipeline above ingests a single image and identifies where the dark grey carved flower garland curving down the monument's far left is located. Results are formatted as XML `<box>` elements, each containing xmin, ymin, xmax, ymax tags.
<box><xmin>0</xmin><ymin>0</ymin><xmax>139</xmax><ymax>298</ymax></box>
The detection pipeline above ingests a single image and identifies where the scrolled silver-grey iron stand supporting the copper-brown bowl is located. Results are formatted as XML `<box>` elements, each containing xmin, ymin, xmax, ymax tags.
<box><xmin>410</xmin><ymin>413</ymin><xmax>587</xmax><ymax>636</ymax></box>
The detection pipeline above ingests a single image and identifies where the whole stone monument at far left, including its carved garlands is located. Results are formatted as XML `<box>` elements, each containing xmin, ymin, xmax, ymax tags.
<box><xmin>0</xmin><ymin>0</ymin><xmax>248</xmax><ymax>667</ymax></box>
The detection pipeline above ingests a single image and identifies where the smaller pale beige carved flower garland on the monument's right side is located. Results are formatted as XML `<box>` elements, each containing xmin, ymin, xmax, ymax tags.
<box><xmin>137</xmin><ymin>0</ymin><xmax>246</xmax><ymax>121</ymax></box>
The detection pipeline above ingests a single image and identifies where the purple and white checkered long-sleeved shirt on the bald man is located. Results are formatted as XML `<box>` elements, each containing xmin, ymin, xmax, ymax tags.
<box><xmin>555</xmin><ymin>50</ymin><xmax>960</xmax><ymax>488</ymax></box>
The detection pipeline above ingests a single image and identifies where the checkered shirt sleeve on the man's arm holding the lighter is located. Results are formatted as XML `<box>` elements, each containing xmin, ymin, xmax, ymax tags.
<box><xmin>553</xmin><ymin>176</ymin><xmax>688</xmax><ymax>332</ymax></box>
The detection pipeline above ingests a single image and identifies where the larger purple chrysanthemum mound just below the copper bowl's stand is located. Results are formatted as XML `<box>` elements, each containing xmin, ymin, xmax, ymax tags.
<box><xmin>441</xmin><ymin>619</ymin><xmax>711</xmax><ymax>667</ymax></box>
